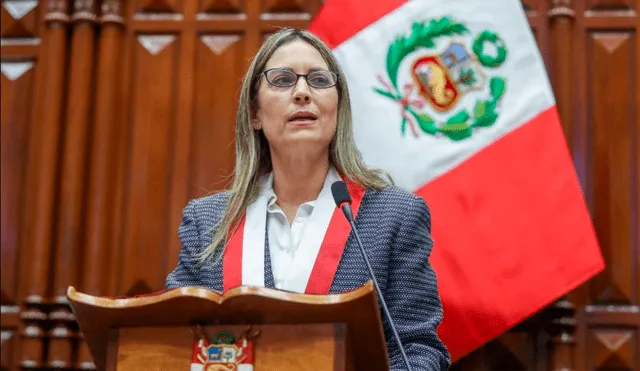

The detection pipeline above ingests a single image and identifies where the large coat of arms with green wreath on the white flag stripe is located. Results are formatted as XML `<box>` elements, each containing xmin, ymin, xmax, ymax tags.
<box><xmin>374</xmin><ymin>17</ymin><xmax>507</xmax><ymax>140</ymax></box>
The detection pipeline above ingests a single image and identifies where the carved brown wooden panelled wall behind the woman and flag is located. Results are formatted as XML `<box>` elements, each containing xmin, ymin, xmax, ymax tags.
<box><xmin>0</xmin><ymin>0</ymin><xmax>640</xmax><ymax>371</ymax></box>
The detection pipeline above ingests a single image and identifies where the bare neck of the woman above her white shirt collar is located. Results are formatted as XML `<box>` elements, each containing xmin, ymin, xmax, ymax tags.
<box><xmin>271</xmin><ymin>151</ymin><xmax>329</xmax><ymax>208</ymax></box>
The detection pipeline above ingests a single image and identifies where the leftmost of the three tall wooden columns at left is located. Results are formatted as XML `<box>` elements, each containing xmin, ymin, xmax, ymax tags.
<box><xmin>18</xmin><ymin>0</ymin><xmax>69</xmax><ymax>370</ymax></box>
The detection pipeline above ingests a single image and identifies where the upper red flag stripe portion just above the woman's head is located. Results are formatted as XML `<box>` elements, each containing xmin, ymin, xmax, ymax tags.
<box><xmin>308</xmin><ymin>0</ymin><xmax>407</xmax><ymax>49</ymax></box>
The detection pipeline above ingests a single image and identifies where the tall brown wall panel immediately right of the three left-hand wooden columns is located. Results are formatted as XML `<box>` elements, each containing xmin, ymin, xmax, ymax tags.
<box><xmin>119</xmin><ymin>34</ymin><xmax>188</xmax><ymax>294</ymax></box>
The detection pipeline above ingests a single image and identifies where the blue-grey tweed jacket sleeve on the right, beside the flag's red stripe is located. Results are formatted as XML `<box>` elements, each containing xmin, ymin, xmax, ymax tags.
<box><xmin>384</xmin><ymin>196</ymin><xmax>451</xmax><ymax>371</ymax></box>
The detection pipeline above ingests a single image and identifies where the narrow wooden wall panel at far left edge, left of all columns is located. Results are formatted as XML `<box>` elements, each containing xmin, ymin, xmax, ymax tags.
<box><xmin>0</xmin><ymin>59</ymin><xmax>37</xmax><ymax>370</ymax></box>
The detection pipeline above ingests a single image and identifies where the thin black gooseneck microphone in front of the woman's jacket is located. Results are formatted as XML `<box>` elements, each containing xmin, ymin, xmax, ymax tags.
<box><xmin>331</xmin><ymin>180</ymin><xmax>412</xmax><ymax>371</ymax></box>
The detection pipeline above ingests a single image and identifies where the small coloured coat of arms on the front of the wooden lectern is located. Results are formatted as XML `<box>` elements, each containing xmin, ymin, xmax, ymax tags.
<box><xmin>190</xmin><ymin>329</ymin><xmax>256</xmax><ymax>371</ymax></box>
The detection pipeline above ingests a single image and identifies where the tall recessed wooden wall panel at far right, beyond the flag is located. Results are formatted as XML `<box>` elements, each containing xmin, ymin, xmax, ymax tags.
<box><xmin>586</xmin><ymin>32</ymin><xmax>640</xmax><ymax>305</ymax></box>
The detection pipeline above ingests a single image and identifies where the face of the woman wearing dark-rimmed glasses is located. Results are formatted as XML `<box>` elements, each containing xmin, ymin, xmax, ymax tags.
<box><xmin>252</xmin><ymin>40</ymin><xmax>338</xmax><ymax>155</ymax></box>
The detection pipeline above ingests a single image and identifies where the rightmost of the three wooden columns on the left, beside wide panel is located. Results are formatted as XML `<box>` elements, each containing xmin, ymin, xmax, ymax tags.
<box><xmin>78</xmin><ymin>0</ymin><xmax>126</xmax><ymax>370</ymax></box>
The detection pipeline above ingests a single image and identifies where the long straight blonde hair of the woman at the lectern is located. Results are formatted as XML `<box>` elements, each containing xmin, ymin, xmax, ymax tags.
<box><xmin>199</xmin><ymin>28</ymin><xmax>390</xmax><ymax>262</ymax></box>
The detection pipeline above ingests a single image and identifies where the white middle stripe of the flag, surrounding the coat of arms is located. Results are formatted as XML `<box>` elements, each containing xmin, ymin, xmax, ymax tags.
<box><xmin>334</xmin><ymin>0</ymin><xmax>555</xmax><ymax>190</ymax></box>
